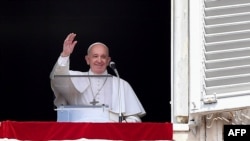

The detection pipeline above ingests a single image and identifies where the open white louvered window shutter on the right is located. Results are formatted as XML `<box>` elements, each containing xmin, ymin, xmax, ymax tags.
<box><xmin>190</xmin><ymin>0</ymin><xmax>250</xmax><ymax>114</ymax></box>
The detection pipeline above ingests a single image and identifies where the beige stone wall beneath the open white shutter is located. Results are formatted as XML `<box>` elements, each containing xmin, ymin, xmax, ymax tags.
<box><xmin>173</xmin><ymin>109</ymin><xmax>250</xmax><ymax>141</ymax></box>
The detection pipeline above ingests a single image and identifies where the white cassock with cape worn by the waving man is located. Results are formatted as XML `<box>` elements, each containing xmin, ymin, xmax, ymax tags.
<box><xmin>50</xmin><ymin>56</ymin><xmax>146</xmax><ymax>122</ymax></box>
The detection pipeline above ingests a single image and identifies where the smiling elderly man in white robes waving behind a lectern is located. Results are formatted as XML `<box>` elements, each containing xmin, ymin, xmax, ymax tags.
<box><xmin>50</xmin><ymin>33</ymin><xmax>146</xmax><ymax>122</ymax></box>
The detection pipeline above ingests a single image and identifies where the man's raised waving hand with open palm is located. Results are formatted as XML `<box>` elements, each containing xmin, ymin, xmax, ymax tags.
<box><xmin>61</xmin><ymin>33</ymin><xmax>77</xmax><ymax>57</ymax></box>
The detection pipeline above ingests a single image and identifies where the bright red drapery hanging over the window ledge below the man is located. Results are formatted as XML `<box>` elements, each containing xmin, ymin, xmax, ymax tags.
<box><xmin>0</xmin><ymin>121</ymin><xmax>173</xmax><ymax>140</ymax></box>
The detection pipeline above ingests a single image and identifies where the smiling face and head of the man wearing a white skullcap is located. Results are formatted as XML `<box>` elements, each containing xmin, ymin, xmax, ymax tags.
<box><xmin>85</xmin><ymin>44</ymin><xmax>111</xmax><ymax>74</ymax></box>
